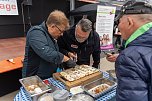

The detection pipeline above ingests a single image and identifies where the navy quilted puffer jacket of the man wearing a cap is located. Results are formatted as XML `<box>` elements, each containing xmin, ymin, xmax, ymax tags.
<box><xmin>115</xmin><ymin>28</ymin><xmax>152</xmax><ymax>101</ymax></box>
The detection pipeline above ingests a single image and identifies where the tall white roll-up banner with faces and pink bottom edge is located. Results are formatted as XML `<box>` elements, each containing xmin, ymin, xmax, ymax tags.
<box><xmin>96</xmin><ymin>5</ymin><xmax>116</xmax><ymax>50</ymax></box>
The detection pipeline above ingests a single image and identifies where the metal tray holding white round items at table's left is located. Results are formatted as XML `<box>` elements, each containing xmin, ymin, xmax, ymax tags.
<box><xmin>19</xmin><ymin>75</ymin><xmax>51</xmax><ymax>97</ymax></box>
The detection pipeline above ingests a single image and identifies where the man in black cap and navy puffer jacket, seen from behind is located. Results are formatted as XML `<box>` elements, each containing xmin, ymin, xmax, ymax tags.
<box><xmin>115</xmin><ymin>0</ymin><xmax>152</xmax><ymax>101</ymax></box>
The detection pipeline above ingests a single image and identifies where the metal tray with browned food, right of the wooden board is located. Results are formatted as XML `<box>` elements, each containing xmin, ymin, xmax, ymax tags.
<box><xmin>83</xmin><ymin>78</ymin><xmax>117</xmax><ymax>98</ymax></box>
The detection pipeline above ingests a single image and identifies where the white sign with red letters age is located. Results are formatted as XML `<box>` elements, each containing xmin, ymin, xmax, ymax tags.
<box><xmin>0</xmin><ymin>0</ymin><xmax>18</xmax><ymax>15</ymax></box>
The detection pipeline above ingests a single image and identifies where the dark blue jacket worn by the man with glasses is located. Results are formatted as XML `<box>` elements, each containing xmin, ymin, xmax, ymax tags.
<box><xmin>22</xmin><ymin>22</ymin><xmax>64</xmax><ymax>79</ymax></box>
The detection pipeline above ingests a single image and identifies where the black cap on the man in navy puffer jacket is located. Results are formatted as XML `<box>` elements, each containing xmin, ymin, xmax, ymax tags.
<box><xmin>115</xmin><ymin>0</ymin><xmax>152</xmax><ymax>21</ymax></box>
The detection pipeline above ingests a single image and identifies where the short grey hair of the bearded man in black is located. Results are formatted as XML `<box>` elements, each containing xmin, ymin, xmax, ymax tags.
<box><xmin>77</xmin><ymin>18</ymin><xmax>92</xmax><ymax>32</ymax></box>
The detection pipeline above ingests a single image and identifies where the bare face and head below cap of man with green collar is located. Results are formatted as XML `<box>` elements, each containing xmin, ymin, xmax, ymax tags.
<box><xmin>118</xmin><ymin>14</ymin><xmax>152</xmax><ymax>40</ymax></box>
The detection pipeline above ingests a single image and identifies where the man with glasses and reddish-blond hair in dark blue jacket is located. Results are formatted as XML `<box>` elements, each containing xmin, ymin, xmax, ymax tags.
<box><xmin>22</xmin><ymin>10</ymin><xmax>76</xmax><ymax>79</ymax></box>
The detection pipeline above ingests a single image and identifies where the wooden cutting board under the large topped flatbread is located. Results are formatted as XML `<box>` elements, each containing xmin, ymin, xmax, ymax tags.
<box><xmin>53</xmin><ymin>72</ymin><xmax>102</xmax><ymax>90</ymax></box>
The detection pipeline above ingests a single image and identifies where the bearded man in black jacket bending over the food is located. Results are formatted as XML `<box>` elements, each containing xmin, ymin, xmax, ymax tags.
<box><xmin>58</xmin><ymin>19</ymin><xmax>100</xmax><ymax>68</ymax></box>
